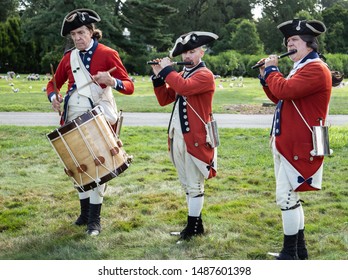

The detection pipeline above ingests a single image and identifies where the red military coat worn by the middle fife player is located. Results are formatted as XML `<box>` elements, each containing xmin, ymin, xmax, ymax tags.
<box><xmin>154</xmin><ymin>64</ymin><xmax>216</xmax><ymax>178</ymax></box>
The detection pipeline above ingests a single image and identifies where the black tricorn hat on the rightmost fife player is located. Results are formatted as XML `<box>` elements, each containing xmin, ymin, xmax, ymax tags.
<box><xmin>277</xmin><ymin>19</ymin><xmax>326</xmax><ymax>42</ymax></box>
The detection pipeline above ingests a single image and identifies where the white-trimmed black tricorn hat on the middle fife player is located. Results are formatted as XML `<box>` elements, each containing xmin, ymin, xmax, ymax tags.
<box><xmin>169</xmin><ymin>31</ymin><xmax>219</xmax><ymax>57</ymax></box>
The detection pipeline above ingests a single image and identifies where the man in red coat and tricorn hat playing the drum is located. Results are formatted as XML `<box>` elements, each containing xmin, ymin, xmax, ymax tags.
<box><xmin>47</xmin><ymin>9</ymin><xmax>134</xmax><ymax>235</ymax></box>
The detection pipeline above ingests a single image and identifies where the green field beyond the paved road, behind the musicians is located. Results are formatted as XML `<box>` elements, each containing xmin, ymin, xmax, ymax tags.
<box><xmin>0</xmin><ymin>74</ymin><xmax>348</xmax><ymax>115</ymax></box>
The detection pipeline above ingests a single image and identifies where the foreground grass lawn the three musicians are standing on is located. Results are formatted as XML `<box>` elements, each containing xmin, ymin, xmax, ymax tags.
<box><xmin>0</xmin><ymin>126</ymin><xmax>348</xmax><ymax>260</ymax></box>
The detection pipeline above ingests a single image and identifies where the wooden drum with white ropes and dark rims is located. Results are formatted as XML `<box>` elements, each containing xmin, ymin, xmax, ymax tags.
<box><xmin>47</xmin><ymin>108</ymin><xmax>130</xmax><ymax>191</ymax></box>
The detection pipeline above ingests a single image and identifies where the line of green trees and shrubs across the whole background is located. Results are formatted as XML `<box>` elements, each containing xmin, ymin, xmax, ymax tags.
<box><xmin>0</xmin><ymin>0</ymin><xmax>348</xmax><ymax>76</ymax></box>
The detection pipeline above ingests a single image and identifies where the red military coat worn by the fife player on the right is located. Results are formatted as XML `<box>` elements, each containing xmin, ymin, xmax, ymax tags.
<box><xmin>264</xmin><ymin>55</ymin><xmax>332</xmax><ymax>190</ymax></box>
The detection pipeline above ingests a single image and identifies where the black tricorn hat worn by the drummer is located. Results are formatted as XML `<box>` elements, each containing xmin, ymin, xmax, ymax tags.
<box><xmin>60</xmin><ymin>9</ymin><xmax>100</xmax><ymax>37</ymax></box>
